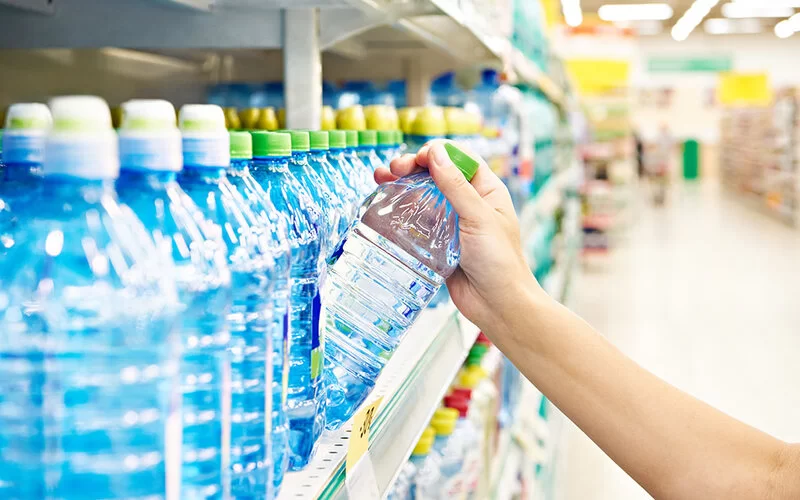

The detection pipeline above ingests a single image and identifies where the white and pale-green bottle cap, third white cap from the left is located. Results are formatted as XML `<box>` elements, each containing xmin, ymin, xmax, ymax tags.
<box><xmin>118</xmin><ymin>99</ymin><xmax>183</xmax><ymax>172</ymax></box>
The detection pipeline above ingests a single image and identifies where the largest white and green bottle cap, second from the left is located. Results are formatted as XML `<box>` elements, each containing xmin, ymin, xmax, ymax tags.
<box><xmin>42</xmin><ymin>96</ymin><xmax>119</xmax><ymax>180</ymax></box>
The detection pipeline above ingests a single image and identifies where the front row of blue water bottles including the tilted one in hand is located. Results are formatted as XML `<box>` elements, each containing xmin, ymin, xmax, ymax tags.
<box><xmin>0</xmin><ymin>97</ymin><xmax>477</xmax><ymax>498</ymax></box>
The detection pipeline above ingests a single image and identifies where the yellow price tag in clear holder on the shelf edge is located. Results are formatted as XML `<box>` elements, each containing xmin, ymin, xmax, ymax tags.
<box><xmin>345</xmin><ymin>397</ymin><xmax>383</xmax><ymax>500</ymax></box>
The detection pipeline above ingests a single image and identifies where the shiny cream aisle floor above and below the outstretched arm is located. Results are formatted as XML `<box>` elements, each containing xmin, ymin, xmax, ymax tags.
<box><xmin>555</xmin><ymin>186</ymin><xmax>800</xmax><ymax>500</ymax></box>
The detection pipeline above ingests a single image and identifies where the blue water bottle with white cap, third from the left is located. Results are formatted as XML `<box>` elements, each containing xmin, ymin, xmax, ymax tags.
<box><xmin>117</xmin><ymin>100</ymin><xmax>231</xmax><ymax>500</ymax></box>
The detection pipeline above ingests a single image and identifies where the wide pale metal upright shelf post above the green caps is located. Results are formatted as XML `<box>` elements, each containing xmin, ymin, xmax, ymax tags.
<box><xmin>282</xmin><ymin>8</ymin><xmax>322</xmax><ymax>130</ymax></box>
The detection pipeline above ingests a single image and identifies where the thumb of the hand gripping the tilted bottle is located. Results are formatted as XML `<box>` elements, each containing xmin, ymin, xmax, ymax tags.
<box><xmin>428</xmin><ymin>141</ymin><xmax>484</xmax><ymax>220</ymax></box>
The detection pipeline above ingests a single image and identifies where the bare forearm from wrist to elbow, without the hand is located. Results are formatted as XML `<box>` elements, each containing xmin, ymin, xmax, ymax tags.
<box><xmin>487</xmin><ymin>280</ymin><xmax>794</xmax><ymax>498</ymax></box>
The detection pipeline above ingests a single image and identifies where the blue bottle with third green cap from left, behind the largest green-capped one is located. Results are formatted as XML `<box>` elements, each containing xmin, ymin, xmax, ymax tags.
<box><xmin>289</xmin><ymin>130</ymin><xmax>334</xmax><ymax>257</ymax></box>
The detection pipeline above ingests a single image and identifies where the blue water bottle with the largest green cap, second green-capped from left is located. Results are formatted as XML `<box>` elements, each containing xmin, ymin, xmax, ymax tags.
<box><xmin>248</xmin><ymin>132</ymin><xmax>326</xmax><ymax>470</ymax></box>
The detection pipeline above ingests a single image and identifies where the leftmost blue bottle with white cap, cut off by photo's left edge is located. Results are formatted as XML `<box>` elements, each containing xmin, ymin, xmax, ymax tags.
<box><xmin>0</xmin><ymin>103</ymin><xmax>53</xmax><ymax>256</ymax></box>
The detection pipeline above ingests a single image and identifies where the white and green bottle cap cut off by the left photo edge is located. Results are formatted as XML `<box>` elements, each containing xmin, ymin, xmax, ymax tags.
<box><xmin>0</xmin><ymin>102</ymin><xmax>53</xmax><ymax>164</ymax></box>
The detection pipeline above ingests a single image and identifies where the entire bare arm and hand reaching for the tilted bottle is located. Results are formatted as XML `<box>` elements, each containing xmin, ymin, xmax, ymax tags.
<box><xmin>376</xmin><ymin>143</ymin><xmax>800</xmax><ymax>500</ymax></box>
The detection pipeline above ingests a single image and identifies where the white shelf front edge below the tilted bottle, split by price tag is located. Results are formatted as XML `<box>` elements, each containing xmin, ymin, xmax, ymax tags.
<box><xmin>280</xmin><ymin>303</ymin><xmax>478</xmax><ymax>499</ymax></box>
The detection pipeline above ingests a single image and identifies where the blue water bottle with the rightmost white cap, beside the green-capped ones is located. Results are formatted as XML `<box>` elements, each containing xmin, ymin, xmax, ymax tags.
<box><xmin>178</xmin><ymin>104</ymin><xmax>275</xmax><ymax>498</ymax></box>
